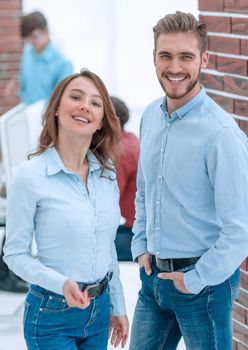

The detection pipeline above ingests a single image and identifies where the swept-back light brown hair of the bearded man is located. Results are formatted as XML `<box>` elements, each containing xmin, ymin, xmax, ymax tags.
<box><xmin>153</xmin><ymin>11</ymin><xmax>207</xmax><ymax>54</ymax></box>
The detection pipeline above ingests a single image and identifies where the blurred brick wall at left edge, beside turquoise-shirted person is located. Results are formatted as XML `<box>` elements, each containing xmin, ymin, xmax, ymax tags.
<box><xmin>0</xmin><ymin>0</ymin><xmax>22</xmax><ymax>115</ymax></box>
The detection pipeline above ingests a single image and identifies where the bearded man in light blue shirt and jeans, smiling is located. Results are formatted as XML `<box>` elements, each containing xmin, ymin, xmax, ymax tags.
<box><xmin>130</xmin><ymin>12</ymin><xmax>248</xmax><ymax>350</ymax></box>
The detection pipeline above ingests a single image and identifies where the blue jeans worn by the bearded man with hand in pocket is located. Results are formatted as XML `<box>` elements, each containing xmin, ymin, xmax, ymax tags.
<box><xmin>129</xmin><ymin>264</ymin><xmax>240</xmax><ymax>350</ymax></box>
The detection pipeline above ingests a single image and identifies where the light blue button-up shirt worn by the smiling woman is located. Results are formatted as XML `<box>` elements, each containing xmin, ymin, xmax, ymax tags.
<box><xmin>4</xmin><ymin>148</ymin><xmax>126</xmax><ymax>316</ymax></box>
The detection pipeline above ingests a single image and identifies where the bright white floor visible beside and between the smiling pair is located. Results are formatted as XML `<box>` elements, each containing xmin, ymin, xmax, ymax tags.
<box><xmin>0</xmin><ymin>262</ymin><xmax>186</xmax><ymax>350</ymax></box>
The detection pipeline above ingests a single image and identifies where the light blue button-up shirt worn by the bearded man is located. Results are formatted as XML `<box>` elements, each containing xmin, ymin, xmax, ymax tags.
<box><xmin>132</xmin><ymin>88</ymin><xmax>248</xmax><ymax>293</ymax></box>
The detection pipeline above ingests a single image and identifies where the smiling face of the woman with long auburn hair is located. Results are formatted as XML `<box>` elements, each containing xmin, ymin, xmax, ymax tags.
<box><xmin>56</xmin><ymin>77</ymin><xmax>104</xmax><ymax>141</ymax></box>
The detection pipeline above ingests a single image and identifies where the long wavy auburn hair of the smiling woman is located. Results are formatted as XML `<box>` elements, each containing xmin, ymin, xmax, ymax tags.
<box><xmin>30</xmin><ymin>68</ymin><xmax>121</xmax><ymax>170</ymax></box>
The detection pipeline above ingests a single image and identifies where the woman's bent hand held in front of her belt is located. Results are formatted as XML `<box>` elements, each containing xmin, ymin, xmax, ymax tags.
<box><xmin>63</xmin><ymin>279</ymin><xmax>90</xmax><ymax>309</ymax></box>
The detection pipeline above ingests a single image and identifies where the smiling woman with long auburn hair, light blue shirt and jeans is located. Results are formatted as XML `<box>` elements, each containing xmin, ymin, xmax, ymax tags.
<box><xmin>4</xmin><ymin>69</ymin><xmax>128</xmax><ymax>350</ymax></box>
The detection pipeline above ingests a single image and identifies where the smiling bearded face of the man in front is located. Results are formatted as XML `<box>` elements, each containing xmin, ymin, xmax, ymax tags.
<box><xmin>154</xmin><ymin>33</ymin><xmax>208</xmax><ymax>110</ymax></box>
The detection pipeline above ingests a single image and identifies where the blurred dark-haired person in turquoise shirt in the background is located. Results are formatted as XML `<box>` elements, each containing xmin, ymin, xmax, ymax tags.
<box><xmin>5</xmin><ymin>11</ymin><xmax>72</xmax><ymax>105</ymax></box>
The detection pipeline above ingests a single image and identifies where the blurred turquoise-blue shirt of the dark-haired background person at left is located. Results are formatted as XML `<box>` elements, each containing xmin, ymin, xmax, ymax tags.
<box><xmin>20</xmin><ymin>43</ymin><xmax>73</xmax><ymax>105</ymax></box>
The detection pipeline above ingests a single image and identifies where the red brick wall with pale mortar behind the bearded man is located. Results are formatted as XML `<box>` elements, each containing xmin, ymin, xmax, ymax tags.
<box><xmin>198</xmin><ymin>0</ymin><xmax>248</xmax><ymax>350</ymax></box>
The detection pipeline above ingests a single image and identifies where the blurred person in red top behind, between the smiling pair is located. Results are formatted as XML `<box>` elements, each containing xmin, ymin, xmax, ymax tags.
<box><xmin>111</xmin><ymin>96</ymin><xmax>140</xmax><ymax>261</ymax></box>
